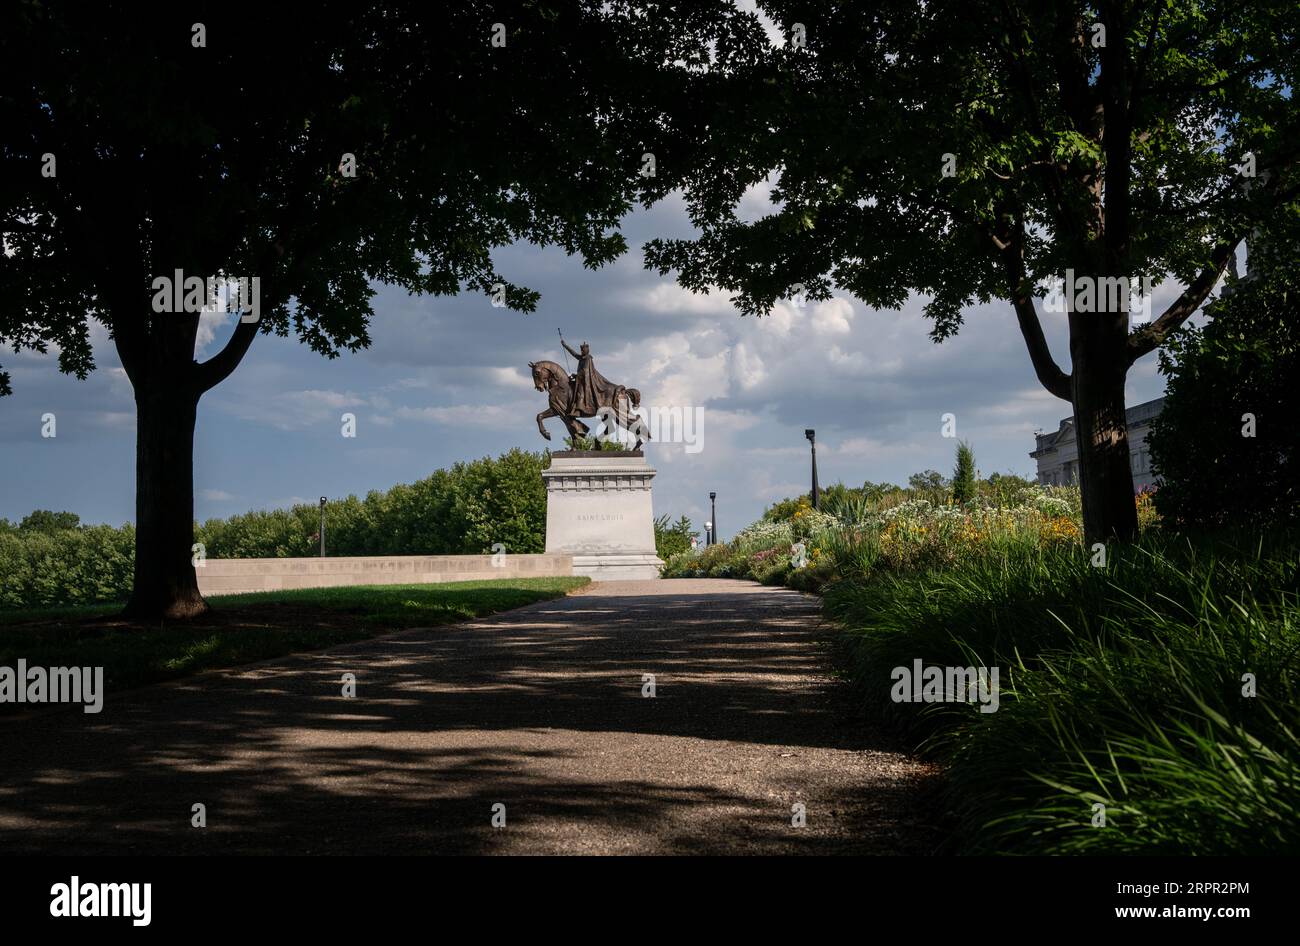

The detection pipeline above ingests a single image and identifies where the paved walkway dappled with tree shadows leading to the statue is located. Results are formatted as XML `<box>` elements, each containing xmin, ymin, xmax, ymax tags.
<box><xmin>0</xmin><ymin>580</ymin><xmax>933</xmax><ymax>854</ymax></box>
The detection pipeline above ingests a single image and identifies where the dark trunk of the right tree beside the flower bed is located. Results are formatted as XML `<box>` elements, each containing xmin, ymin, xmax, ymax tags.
<box><xmin>1070</xmin><ymin>312</ymin><xmax>1138</xmax><ymax>544</ymax></box>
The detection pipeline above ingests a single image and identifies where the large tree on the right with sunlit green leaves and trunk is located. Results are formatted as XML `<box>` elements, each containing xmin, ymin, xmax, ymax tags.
<box><xmin>647</xmin><ymin>0</ymin><xmax>1300</xmax><ymax>541</ymax></box>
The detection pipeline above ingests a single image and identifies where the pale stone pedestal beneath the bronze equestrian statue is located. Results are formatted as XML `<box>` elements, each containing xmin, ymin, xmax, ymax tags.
<box><xmin>542</xmin><ymin>450</ymin><xmax>663</xmax><ymax>581</ymax></box>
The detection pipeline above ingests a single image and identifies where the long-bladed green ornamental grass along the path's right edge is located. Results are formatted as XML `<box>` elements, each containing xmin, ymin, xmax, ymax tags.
<box><xmin>826</xmin><ymin>531</ymin><xmax>1300</xmax><ymax>855</ymax></box>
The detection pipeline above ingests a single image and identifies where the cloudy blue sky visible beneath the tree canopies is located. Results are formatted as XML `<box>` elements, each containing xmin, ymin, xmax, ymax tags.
<box><xmin>0</xmin><ymin>188</ymin><xmax>1179</xmax><ymax>538</ymax></box>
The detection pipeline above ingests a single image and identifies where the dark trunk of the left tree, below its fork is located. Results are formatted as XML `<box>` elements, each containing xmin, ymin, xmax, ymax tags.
<box><xmin>125</xmin><ymin>377</ymin><xmax>208</xmax><ymax>620</ymax></box>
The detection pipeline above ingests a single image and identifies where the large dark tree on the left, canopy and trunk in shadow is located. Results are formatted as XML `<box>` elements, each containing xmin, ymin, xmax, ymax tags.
<box><xmin>0</xmin><ymin>0</ymin><xmax>733</xmax><ymax>617</ymax></box>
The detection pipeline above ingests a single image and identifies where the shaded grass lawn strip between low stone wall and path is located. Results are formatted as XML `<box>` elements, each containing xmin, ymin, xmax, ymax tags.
<box><xmin>0</xmin><ymin>578</ymin><xmax>589</xmax><ymax>713</ymax></box>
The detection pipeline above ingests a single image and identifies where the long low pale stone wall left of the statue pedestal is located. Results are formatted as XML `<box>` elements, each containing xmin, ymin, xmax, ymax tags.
<box><xmin>195</xmin><ymin>552</ymin><xmax>573</xmax><ymax>595</ymax></box>
